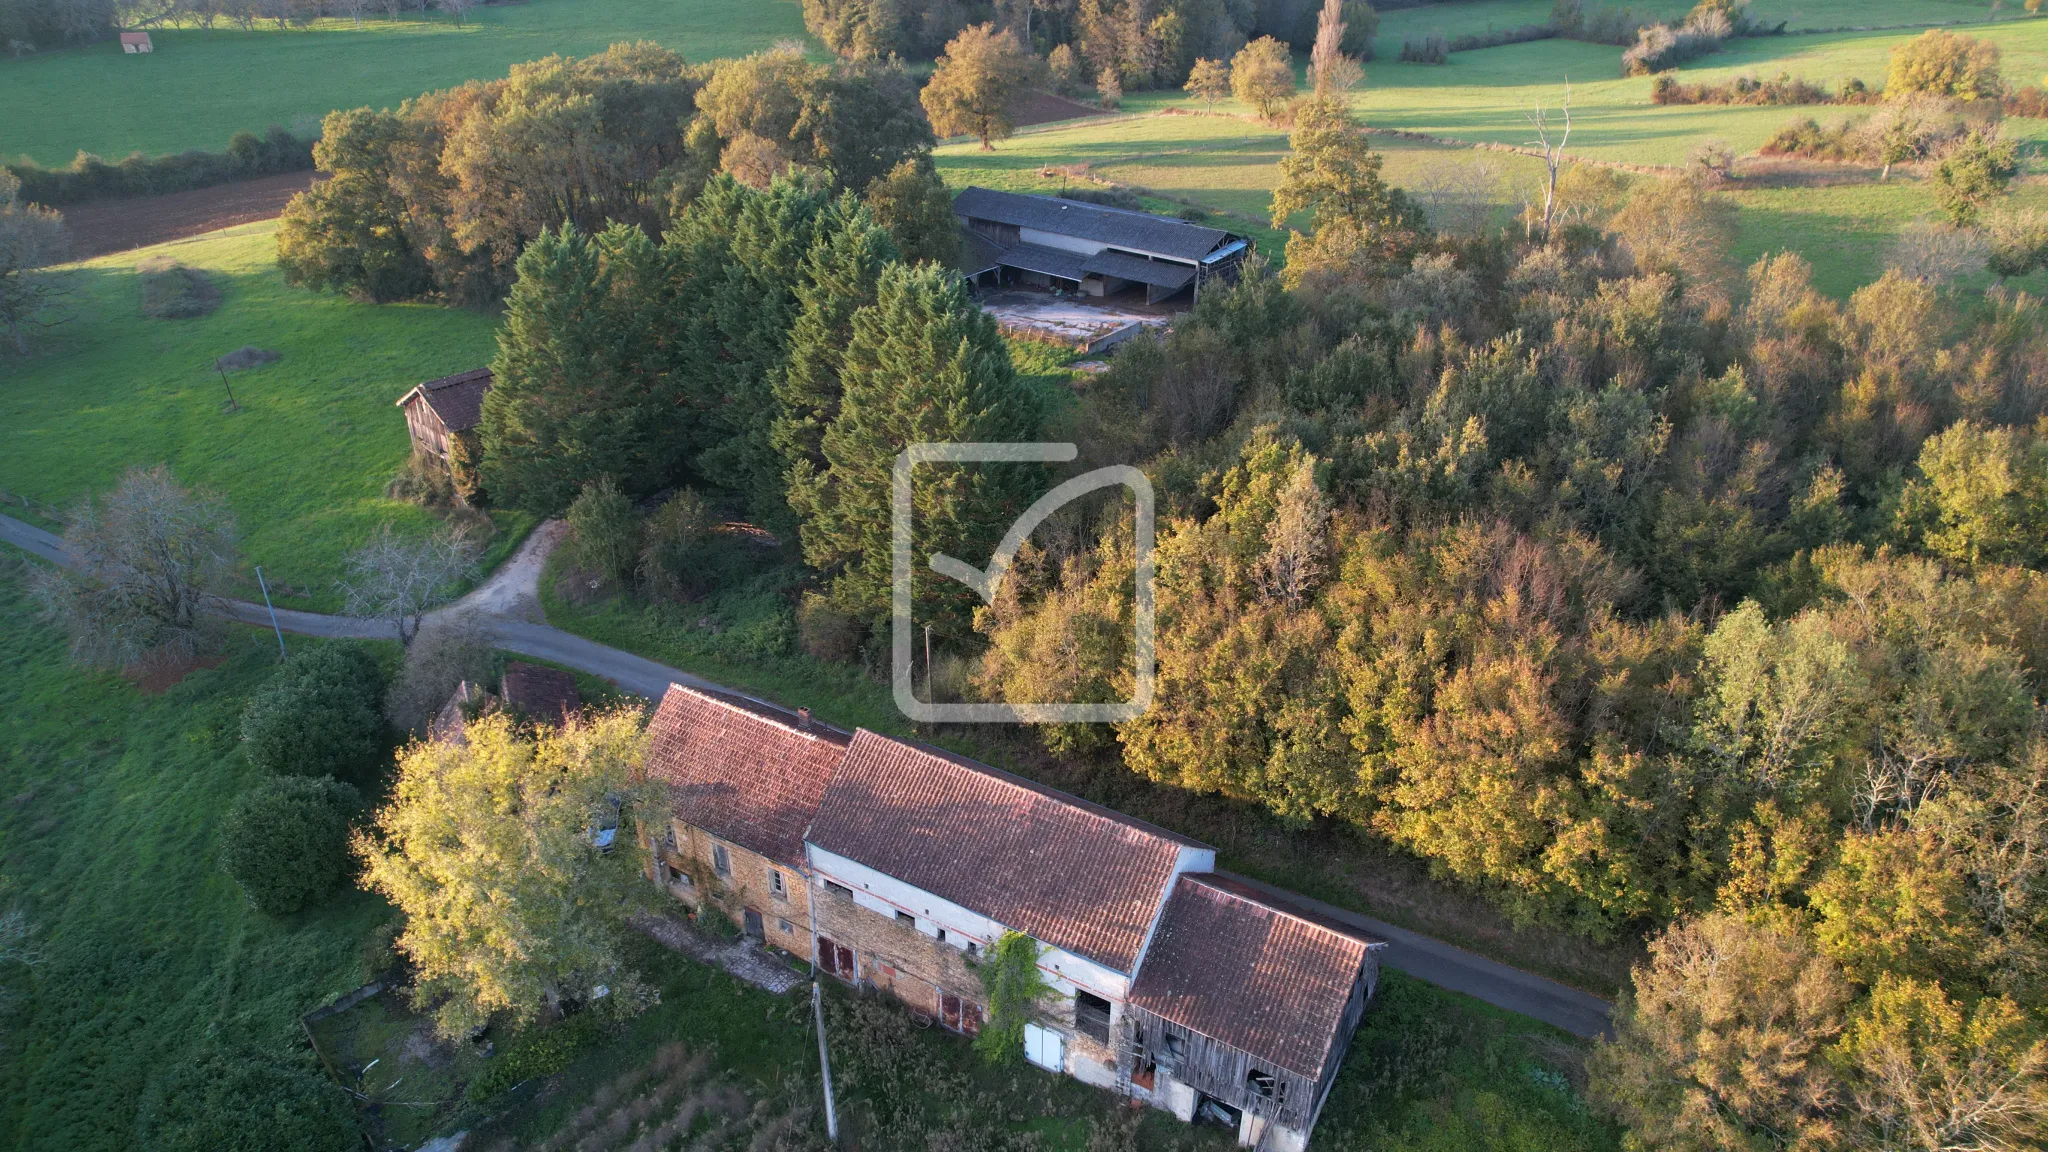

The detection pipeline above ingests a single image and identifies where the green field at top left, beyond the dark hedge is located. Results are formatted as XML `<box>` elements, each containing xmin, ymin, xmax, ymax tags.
<box><xmin>0</xmin><ymin>0</ymin><xmax>803</xmax><ymax>164</ymax></box>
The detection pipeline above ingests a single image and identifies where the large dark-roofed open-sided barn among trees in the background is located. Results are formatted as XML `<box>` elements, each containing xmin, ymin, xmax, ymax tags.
<box><xmin>952</xmin><ymin>189</ymin><xmax>1251</xmax><ymax>303</ymax></box>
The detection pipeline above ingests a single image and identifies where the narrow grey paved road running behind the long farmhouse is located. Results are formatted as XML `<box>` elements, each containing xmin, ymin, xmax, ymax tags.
<box><xmin>0</xmin><ymin>508</ymin><xmax>1612</xmax><ymax>1037</ymax></box>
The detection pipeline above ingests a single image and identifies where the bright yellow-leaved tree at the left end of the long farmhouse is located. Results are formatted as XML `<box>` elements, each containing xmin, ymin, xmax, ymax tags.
<box><xmin>356</xmin><ymin>709</ymin><xmax>659</xmax><ymax>1037</ymax></box>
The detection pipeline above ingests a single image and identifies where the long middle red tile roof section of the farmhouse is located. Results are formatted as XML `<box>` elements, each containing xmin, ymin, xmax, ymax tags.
<box><xmin>809</xmin><ymin>730</ymin><xmax>1204</xmax><ymax>972</ymax></box>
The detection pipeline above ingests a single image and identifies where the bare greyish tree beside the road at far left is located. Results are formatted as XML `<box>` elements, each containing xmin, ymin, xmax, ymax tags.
<box><xmin>37</xmin><ymin>465</ymin><xmax>236</xmax><ymax>668</ymax></box>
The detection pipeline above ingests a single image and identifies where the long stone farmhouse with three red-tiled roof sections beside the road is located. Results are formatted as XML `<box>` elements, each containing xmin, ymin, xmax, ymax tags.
<box><xmin>643</xmin><ymin>685</ymin><xmax>1384</xmax><ymax>1152</ymax></box>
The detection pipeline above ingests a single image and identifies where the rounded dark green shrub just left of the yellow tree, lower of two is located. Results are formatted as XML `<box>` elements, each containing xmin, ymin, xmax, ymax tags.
<box><xmin>221</xmin><ymin>777</ymin><xmax>360</xmax><ymax>916</ymax></box>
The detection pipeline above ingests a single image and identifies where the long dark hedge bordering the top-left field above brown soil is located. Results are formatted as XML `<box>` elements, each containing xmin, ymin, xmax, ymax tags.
<box><xmin>8</xmin><ymin>125</ymin><xmax>313</xmax><ymax>207</ymax></box>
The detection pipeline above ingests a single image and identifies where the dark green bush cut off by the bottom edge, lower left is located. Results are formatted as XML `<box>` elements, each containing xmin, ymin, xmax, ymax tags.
<box><xmin>143</xmin><ymin>1045</ymin><xmax>362</xmax><ymax>1152</ymax></box>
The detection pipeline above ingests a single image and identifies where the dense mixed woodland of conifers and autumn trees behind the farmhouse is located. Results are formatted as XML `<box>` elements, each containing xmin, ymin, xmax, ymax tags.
<box><xmin>56</xmin><ymin>2</ymin><xmax>2048</xmax><ymax>1150</ymax></box>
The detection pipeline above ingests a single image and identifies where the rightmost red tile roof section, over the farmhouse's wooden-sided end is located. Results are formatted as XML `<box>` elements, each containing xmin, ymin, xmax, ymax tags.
<box><xmin>1130</xmin><ymin>873</ymin><xmax>1372</xmax><ymax>1080</ymax></box>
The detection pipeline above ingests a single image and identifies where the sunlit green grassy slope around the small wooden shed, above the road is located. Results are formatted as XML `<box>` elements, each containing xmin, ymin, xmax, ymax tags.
<box><xmin>0</xmin><ymin>223</ymin><xmax>518</xmax><ymax>609</ymax></box>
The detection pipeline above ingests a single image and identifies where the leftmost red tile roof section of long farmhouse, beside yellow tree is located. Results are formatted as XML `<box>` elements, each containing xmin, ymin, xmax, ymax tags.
<box><xmin>647</xmin><ymin>685</ymin><xmax>848</xmax><ymax>865</ymax></box>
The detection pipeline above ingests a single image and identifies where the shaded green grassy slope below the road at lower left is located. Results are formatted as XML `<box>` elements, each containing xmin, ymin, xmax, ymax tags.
<box><xmin>0</xmin><ymin>558</ymin><xmax>387</xmax><ymax>1152</ymax></box>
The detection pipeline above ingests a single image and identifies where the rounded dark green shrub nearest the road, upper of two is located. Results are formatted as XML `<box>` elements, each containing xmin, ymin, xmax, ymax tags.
<box><xmin>242</xmin><ymin>644</ymin><xmax>383</xmax><ymax>777</ymax></box>
